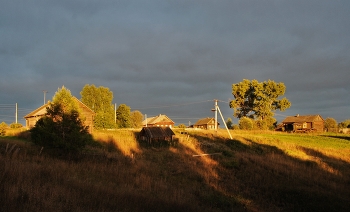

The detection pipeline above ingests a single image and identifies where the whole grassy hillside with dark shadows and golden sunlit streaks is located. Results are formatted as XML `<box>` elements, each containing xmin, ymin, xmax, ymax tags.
<box><xmin>0</xmin><ymin>130</ymin><xmax>350</xmax><ymax>211</ymax></box>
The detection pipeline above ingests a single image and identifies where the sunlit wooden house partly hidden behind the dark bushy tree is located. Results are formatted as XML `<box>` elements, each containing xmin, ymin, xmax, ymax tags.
<box><xmin>24</xmin><ymin>97</ymin><xmax>95</xmax><ymax>133</ymax></box>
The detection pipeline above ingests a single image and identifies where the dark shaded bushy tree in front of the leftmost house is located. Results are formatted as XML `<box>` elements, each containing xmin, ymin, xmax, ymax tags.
<box><xmin>30</xmin><ymin>104</ymin><xmax>92</xmax><ymax>153</ymax></box>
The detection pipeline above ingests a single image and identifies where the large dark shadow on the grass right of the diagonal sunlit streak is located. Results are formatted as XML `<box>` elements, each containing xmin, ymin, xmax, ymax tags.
<box><xmin>186</xmin><ymin>130</ymin><xmax>350</xmax><ymax>211</ymax></box>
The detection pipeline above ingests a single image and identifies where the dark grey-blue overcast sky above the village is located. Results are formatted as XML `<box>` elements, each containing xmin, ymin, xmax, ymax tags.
<box><xmin>0</xmin><ymin>0</ymin><xmax>350</xmax><ymax>125</ymax></box>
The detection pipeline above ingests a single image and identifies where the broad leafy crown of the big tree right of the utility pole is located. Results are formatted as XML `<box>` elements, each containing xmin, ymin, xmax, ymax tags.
<box><xmin>230</xmin><ymin>79</ymin><xmax>291</xmax><ymax>120</ymax></box>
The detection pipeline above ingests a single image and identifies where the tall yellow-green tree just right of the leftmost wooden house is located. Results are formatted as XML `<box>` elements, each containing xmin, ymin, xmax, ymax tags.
<box><xmin>80</xmin><ymin>85</ymin><xmax>115</xmax><ymax>129</ymax></box>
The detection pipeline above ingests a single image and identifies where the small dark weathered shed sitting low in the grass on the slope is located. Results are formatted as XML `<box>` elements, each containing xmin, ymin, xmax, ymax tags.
<box><xmin>140</xmin><ymin>127</ymin><xmax>175</xmax><ymax>143</ymax></box>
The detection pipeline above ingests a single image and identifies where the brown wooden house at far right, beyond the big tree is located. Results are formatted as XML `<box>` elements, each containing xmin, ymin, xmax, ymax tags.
<box><xmin>282</xmin><ymin>115</ymin><xmax>324</xmax><ymax>132</ymax></box>
